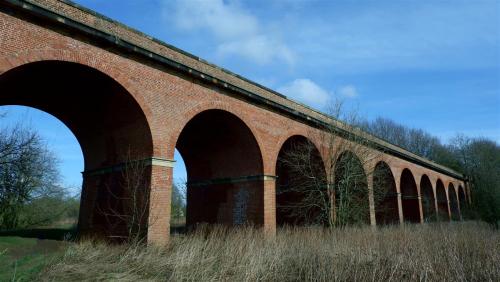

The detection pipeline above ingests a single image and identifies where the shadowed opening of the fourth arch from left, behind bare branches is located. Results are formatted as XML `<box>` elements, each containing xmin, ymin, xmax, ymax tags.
<box><xmin>334</xmin><ymin>151</ymin><xmax>370</xmax><ymax>225</ymax></box>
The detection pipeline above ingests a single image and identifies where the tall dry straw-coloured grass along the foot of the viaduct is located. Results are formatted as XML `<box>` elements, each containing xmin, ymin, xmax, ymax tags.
<box><xmin>40</xmin><ymin>222</ymin><xmax>500</xmax><ymax>281</ymax></box>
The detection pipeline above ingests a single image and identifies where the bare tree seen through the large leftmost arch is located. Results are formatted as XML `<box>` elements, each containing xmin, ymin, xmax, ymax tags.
<box><xmin>0</xmin><ymin>121</ymin><xmax>62</xmax><ymax>229</ymax></box>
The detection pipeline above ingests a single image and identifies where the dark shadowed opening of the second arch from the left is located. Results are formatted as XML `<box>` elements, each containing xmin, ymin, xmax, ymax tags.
<box><xmin>176</xmin><ymin>109</ymin><xmax>266</xmax><ymax>228</ymax></box>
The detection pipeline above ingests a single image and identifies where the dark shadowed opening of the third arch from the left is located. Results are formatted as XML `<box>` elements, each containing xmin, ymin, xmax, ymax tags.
<box><xmin>276</xmin><ymin>135</ymin><xmax>330</xmax><ymax>226</ymax></box>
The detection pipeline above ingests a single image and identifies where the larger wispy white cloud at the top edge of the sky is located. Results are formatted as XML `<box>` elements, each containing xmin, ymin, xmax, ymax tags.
<box><xmin>163</xmin><ymin>0</ymin><xmax>294</xmax><ymax>65</ymax></box>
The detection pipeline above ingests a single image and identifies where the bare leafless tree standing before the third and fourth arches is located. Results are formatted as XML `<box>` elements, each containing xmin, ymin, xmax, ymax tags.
<box><xmin>277</xmin><ymin>101</ymin><xmax>387</xmax><ymax>226</ymax></box>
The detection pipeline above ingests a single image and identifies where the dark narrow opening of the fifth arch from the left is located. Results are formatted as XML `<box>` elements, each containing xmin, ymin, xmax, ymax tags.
<box><xmin>373</xmin><ymin>161</ymin><xmax>399</xmax><ymax>225</ymax></box>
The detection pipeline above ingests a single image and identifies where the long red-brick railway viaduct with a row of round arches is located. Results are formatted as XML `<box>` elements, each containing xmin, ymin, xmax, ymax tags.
<box><xmin>0</xmin><ymin>0</ymin><xmax>470</xmax><ymax>244</ymax></box>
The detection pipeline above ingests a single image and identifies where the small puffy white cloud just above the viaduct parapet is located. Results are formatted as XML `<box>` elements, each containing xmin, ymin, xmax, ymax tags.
<box><xmin>278</xmin><ymin>78</ymin><xmax>330</xmax><ymax>108</ymax></box>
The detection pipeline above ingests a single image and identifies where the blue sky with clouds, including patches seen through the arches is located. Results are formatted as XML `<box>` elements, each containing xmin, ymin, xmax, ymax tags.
<box><xmin>0</xmin><ymin>0</ymin><xmax>500</xmax><ymax>192</ymax></box>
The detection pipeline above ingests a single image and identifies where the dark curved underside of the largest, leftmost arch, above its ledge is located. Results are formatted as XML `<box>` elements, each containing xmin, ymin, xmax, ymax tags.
<box><xmin>0</xmin><ymin>60</ymin><xmax>154</xmax><ymax>170</ymax></box>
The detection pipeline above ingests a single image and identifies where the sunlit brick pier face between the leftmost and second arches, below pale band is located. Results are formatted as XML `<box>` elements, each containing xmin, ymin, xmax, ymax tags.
<box><xmin>147</xmin><ymin>165</ymin><xmax>173</xmax><ymax>246</ymax></box>
